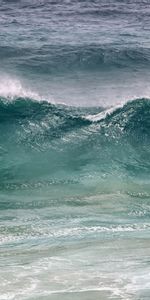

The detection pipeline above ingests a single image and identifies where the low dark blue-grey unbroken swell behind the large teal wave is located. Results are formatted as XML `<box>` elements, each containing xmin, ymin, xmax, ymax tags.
<box><xmin>0</xmin><ymin>42</ymin><xmax>150</xmax><ymax>74</ymax></box>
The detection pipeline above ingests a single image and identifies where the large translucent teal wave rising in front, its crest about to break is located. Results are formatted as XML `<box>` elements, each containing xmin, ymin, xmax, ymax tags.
<box><xmin>0</xmin><ymin>98</ymin><xmax>150</xmax><ymax>190</ymax></box>
